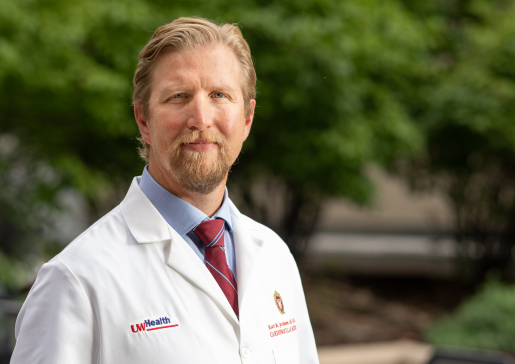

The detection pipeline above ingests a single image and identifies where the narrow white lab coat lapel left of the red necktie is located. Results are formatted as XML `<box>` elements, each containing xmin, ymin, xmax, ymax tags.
<box><xmin>167</xmin><ymin>227</ymin><xmax>239</xmax><ymax>326</ymax></box>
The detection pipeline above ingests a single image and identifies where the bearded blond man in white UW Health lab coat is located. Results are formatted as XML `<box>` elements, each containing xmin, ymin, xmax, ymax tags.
<box><xmin>11</xmin><ymin>18</ymin><xmax>318</xmax><ymax>364</ymax></box>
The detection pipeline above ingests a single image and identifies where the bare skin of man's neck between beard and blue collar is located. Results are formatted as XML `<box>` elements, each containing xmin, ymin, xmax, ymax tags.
<box><xmin>148</xmin><ymin>160</ymin><xmax>227</xmax><ymax>217</ymax></box>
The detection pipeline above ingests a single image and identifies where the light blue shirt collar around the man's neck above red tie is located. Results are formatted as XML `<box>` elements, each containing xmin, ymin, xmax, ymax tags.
<box><xmin>139</xmin><ymin>166</ymin><xmax>232</xmax><ymax>236</ymax></box>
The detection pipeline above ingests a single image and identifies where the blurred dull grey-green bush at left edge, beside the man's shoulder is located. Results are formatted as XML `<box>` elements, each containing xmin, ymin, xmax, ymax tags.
<box><xmin>0</xmin><ymin>134</ymin><xmax>60</xmax><ymax>292</ymax></box>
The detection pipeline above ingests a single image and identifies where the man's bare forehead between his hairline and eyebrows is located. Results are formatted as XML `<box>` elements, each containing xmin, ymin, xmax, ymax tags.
<box><xmin>152</xmin><ymin>45</ymin><xmax>241</xmax><ymax>92</ymax></box>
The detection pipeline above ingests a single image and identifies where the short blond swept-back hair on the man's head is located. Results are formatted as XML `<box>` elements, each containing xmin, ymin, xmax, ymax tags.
<box><xmin>132</xmin><ymin>18</ymin><xmax>256</xmax><ymax>163</ymax></box>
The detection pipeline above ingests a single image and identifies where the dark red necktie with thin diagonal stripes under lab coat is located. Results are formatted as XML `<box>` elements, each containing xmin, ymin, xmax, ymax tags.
<box><xmin>194</xmin><ymin>219</ymin><xmax>240</xmax><ymax>318</ymax></box>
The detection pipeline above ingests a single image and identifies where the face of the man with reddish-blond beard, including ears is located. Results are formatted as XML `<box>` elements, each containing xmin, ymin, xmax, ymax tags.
<box><xmin>137</xmin><ymin>46</ymin><xmax>255</xmax><ymax>194</ymax></box>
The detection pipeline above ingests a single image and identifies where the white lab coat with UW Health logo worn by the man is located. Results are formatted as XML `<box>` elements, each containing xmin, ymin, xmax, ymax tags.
<box><xmin>11</xmin><ymin>178</ymin><xmax>318</xmax><ymax>364</ymax></box>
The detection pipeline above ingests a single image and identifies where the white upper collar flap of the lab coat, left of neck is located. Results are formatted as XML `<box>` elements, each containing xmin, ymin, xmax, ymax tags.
<box><xmin>120</xmin><ymin>177</ymin><xmax>170</xmax><ymax>243</ymax></box>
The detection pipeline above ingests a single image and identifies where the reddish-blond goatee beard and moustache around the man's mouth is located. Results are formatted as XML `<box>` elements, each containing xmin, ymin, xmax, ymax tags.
<box><xmin>168</xmin><ymin>130</ymin><xmax>232</xmax><ymax>195</ymax></box>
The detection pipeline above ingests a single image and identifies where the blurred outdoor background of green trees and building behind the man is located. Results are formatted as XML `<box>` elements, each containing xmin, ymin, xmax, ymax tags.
<box><xmin>0</xmin><ymin>0</ymin><xmax>515</xmax><ymax>362</ymax></box>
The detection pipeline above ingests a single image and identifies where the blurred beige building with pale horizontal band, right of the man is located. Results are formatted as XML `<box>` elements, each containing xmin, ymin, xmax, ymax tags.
<box><xmin>310</xmin><ymin>168</ymin><xmax>455</xmax><ymax>277</ymax></box>
